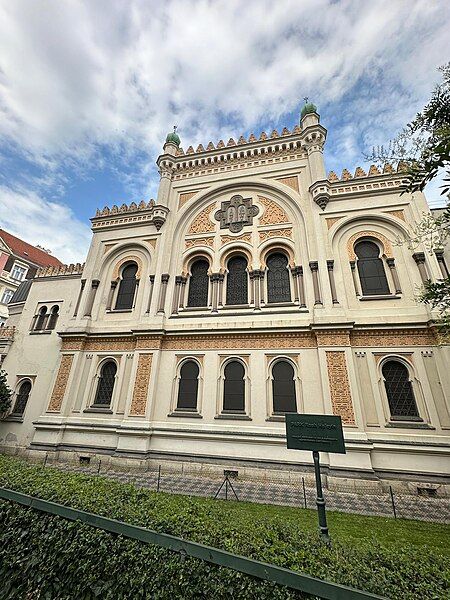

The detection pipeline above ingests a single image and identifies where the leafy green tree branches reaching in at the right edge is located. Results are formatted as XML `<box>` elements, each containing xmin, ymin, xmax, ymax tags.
<box><xmin>366</xmin><ymin>63</ymin><xmax>450</xmax><ymax>336</ymax></box>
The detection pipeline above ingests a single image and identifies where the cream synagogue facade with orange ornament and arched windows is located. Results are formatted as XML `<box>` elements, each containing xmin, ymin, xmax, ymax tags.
<box><xmin>0</xmin><ymin>105</ymin><xmax>450</xmax><ymax>490</ymax></box>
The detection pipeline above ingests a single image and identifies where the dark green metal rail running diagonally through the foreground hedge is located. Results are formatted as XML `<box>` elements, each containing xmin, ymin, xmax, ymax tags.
<box><xmin>0</xmin><ymin>488</ymin><xmax>383</xmax><ymax>600</ymax></box>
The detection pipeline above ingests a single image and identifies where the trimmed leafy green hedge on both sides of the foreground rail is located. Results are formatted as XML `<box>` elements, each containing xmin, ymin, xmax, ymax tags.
<box><xmin>0</xmin><ymin>456</ymin><xmax>450</xmax><ymax>600</ymax></box>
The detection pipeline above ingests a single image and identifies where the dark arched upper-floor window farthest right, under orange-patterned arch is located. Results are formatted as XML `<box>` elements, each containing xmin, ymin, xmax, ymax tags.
<box><xmin>355</xmin><ymin>240</ymin><xmax>390</xmax><ymax>296</ymax></box>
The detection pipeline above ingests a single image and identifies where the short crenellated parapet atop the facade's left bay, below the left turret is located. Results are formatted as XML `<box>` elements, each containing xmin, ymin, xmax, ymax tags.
<box><xmin>91</xmin><ymin>200</ymin><xmax>169</xmax><ymax>231</ymax></box>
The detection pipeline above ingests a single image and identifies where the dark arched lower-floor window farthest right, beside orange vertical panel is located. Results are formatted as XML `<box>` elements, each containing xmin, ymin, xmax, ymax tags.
<box><xmin>381</xmin><ymin>360</ymin><xmax>420</xmax><ymax>420</ymax></box>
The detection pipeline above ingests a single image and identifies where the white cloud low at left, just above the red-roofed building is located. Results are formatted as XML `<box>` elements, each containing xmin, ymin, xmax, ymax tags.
<box><xmin>0</xmin><ymin>186</ymin><xmax>91</xmax><ymax>262</ymax></box>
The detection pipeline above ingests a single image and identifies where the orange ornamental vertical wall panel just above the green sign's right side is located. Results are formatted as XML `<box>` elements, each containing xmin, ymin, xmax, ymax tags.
<box><xmin>326</xmin><ymin>350</ymin><xmax>355</xmax><ymax>425</ymax></box>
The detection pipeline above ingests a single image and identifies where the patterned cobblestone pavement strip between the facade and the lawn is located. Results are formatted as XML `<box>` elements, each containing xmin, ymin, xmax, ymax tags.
<box><xmin>52</xmin><ymin>464</ymin><xmax>450</xmax><ymax>523</ymax></box>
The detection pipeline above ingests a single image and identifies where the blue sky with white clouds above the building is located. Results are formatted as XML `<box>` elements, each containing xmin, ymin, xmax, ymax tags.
<box><xmin>0</xmin><ymin>0</ymin><xmax>450</xmax><ymax>262</ymax></box>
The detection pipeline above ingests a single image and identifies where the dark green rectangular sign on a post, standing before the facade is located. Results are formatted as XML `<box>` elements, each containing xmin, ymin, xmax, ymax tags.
<box><xmin>286</xmin><ymin>413</ymin><xmax>345</xmax><ymax>542</ymax></box>
